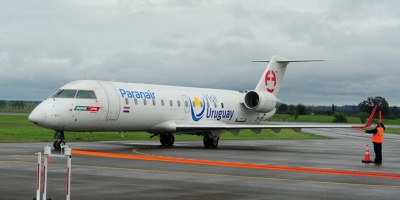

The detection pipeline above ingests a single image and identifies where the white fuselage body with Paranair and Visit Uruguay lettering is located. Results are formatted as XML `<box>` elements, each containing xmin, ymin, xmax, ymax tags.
<box><xmin>30</xmin><ymin>80</ymin><xmax>276</xmax><ymax>133</ymax></box>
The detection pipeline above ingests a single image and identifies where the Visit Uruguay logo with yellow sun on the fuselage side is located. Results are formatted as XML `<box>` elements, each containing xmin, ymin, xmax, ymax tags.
<box><xmin>189</xmin><ymin>95</ymin><xmax>235</xmax><ymax>122</ymax></box>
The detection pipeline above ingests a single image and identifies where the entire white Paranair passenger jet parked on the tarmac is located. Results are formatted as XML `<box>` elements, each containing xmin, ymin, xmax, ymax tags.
<box><xmin>29</xmin><ymin>56</ymin><xmax>376</xmax><ymax>149</ymax></box>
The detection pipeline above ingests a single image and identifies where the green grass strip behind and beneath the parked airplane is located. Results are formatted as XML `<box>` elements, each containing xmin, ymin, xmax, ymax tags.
<box><xmin>0</xmin><ymin>115</ymin><xmax>327</xmax><ymax>142</ymax></box>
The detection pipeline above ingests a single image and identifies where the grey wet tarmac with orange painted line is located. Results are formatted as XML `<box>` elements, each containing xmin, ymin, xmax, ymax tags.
<box><xmin>0</xmin><ymin>129</ymin><xmax>400</xmax><ymax>200</ymax></box>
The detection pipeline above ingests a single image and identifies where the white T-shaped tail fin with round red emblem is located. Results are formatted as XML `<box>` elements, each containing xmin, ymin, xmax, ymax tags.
<box><xmin>253</xmin><ymin>56</ymin><xmax>327</xmax><ymax>97</ymax></box>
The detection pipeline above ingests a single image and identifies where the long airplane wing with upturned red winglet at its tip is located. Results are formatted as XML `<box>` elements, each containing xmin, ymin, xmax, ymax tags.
<box><xmin>175</xmin><ymin>106</ymin><xmax>377</xmax><ymax>132</ymax></box>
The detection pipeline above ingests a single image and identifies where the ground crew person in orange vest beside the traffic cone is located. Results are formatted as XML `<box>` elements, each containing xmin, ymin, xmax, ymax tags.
<box><xmin>365</xmin><ymin>122</ymin><xmax>385</xmax><ymax>165</ymax></box>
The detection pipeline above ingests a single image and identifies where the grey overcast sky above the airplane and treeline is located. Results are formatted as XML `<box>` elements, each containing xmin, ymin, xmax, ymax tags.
<box><xmin>0</xmin><ymin>0</ymin><xmax>400</xmax><ymax>106</ymax></box>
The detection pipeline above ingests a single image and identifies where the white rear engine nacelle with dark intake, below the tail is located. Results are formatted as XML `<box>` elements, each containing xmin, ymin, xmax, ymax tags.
<box><xmin>244</xmin><ymin>91</ymin><xmax>277</xmax><ymax>113</ymax></box>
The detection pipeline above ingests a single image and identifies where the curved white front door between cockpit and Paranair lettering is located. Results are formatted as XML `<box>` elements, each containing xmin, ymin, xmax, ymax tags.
<box><xmin>100</xmin><ymin>82</ymin><xmax>121</xmax><ymax>120</ymax></box>
